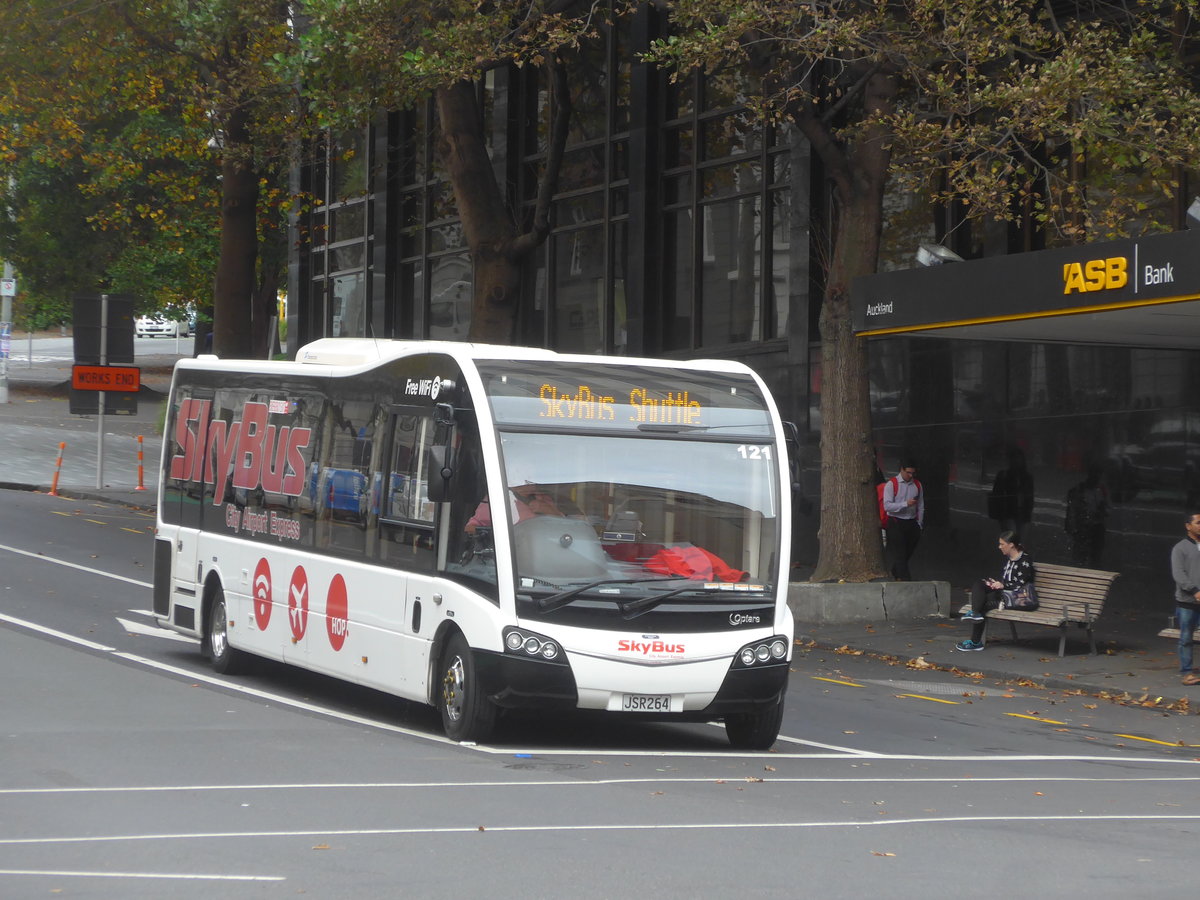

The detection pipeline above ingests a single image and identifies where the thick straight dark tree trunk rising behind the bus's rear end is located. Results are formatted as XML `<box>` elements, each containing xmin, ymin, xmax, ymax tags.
<box><xmin>212</xmin><ymin>103</ymin><xmax>258</xmax><ymax>359</ymax></box>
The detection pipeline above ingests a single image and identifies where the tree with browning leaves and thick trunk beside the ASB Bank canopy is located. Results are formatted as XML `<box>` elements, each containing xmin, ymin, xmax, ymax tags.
<box><xmin>649</xmin><ymin>0</ymin><xmax>1200</xmax><ymax>581</ymax></box>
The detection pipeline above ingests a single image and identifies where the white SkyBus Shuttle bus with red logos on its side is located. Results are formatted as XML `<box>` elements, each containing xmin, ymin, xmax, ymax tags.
<box><xmin>154</xmin><ymin>338</ymin><xmax>792</xmax><ymax>749</ymax></box>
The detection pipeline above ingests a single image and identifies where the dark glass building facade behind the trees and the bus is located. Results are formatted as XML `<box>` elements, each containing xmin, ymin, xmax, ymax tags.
<box><xmin>288</xmin><ymin>5</ymin><xmax>1200</xmax><ymax>580</ymax></box>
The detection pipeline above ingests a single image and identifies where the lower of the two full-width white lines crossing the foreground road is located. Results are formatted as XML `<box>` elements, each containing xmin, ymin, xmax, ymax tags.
<box><xmin>0</xmin><ymin>812</ymin><xmax>1200</xmax><ymax>846</ymax></box>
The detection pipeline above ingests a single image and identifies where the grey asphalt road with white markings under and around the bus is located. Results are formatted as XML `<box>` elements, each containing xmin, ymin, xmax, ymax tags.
<box><xmin>0</xmin><ymin>492</ymin><xmax>1200</xmax><ymax>898</ymax></box>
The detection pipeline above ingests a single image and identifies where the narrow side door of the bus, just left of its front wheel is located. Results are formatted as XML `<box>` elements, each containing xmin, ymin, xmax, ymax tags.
<box><xmin>378</xmin><ymin>407</ymin><xmax>438</xmax><ymax>690</ymax></box>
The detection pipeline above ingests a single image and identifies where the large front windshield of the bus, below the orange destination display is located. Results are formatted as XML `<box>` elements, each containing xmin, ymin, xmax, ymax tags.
<box><xmin>500</xmin><ymin>432</ymin><xmax>779</xmax><ymax>600</ymax></box>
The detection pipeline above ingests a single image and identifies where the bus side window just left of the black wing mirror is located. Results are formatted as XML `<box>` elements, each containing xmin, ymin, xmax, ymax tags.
<box><xmin>379</xmin><ymin>413</ymin><xmax>437</xmax><ymax>572</ymax></box>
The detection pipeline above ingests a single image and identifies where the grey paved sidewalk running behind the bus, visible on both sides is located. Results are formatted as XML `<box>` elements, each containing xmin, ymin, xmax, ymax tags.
<box><xmin>0</xmin><ymin>353</ymin><xmax>1200</xmax><ymax>716</ymax></box>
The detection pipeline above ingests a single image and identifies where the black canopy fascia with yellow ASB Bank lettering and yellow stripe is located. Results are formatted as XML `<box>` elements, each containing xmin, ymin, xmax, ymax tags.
<box><xmin>852</xmin><ymin>232</ymin><xmax>1200</xmax><ymax>335</ymax></box>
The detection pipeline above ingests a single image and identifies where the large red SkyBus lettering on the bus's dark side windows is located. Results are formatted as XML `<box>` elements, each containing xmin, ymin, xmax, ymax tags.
<box><xmin>170</xmin><ymin>400</ymin><xmax>312</xmax><ymax>506</ymax></box>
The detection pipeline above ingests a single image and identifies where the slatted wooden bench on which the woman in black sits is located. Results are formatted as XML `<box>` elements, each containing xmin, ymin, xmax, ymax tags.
<box><xmin>983</xmin><ymin>563</ymin><xmax>1120</xmax><ymax>656</ymax></box>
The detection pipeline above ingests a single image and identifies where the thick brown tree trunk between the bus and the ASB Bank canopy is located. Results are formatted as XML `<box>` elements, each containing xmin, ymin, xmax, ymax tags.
<box><xmin>812</xmin><ymin>72</ymin><xmax>895</xmax><ymax>582</ymax></box>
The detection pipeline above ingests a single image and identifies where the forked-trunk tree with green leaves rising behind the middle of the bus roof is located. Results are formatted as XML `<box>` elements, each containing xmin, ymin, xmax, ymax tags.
<box><xmin>296</xmin><ymin>0</ymin><xmax>629</xmax><ymax>343</ymax></box>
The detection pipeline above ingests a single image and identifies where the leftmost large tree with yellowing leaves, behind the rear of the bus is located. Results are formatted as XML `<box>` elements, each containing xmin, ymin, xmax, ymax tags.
<box><xmin>0</xmin><ymin>0</ymin><xmax>301</xmax><ymax>356</ymax></box>
